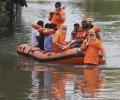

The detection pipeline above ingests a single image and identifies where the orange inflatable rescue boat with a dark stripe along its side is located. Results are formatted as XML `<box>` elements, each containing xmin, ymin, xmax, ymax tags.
<box><xmin>17</xmin><ymin>44</ymin><xmax>105</xmax><ymax>65</ymax></box>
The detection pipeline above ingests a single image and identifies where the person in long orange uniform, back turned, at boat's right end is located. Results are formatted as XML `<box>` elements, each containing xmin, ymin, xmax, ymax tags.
<box><xmin>80</xmin><ymin>28</ymin><xmax>106</xmax><ymax>65</ymax></box>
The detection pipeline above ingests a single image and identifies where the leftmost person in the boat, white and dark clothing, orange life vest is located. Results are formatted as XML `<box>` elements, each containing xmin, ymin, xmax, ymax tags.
<box><xmin>32</xmin><ymin>20</ymin><xmax>44</xmax><ymax>50</ymax></box>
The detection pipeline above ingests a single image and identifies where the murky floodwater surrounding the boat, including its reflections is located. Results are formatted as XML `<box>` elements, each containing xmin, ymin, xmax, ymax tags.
<box><xmin>0</xmin><ymin>0</ymin><xmax>120</xmax><ymax>100</ymax></box>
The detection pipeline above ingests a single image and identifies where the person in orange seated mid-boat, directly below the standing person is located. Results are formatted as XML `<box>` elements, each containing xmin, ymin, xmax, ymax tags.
<box><xmin>52</xmin><ymin>26</ymin><xmax>67</xmax><ymax>52</ymax></box>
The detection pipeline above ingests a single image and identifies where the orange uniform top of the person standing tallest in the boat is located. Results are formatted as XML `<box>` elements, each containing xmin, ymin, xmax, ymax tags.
<box><xmin>49</xmin><ymin>8</ymin><xmax>66</xmax><ymax>29</ymax></box>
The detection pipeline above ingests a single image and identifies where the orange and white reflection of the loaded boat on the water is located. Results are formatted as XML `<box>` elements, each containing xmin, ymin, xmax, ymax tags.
<box><xmin>20</xmin><ymin>57</ymin><xmax>105</xmax><ymax>100</ymax></box>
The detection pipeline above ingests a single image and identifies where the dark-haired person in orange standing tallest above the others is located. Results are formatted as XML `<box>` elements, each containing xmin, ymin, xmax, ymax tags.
<box><xmin>48</xmin><ymin>2</ymin><xmax>66</xmax><ymax>29</ymax></box>
